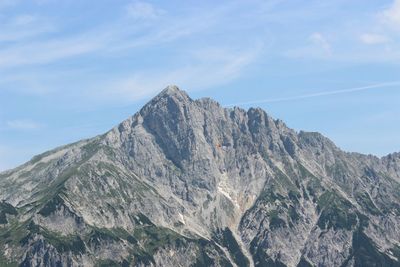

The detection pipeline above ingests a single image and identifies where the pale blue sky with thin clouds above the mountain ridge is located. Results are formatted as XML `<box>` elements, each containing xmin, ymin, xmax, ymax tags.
<box><xmin>0</xmin><ymin>0</ymin><xmax>400</xmax><ymax>171</ymax></box>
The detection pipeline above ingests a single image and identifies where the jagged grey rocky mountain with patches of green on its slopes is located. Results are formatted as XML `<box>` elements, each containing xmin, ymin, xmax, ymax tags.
<box><xmin>0</xmin><ymin>86</ymin><xmax>400</xmax><ymax>267</ymax></box>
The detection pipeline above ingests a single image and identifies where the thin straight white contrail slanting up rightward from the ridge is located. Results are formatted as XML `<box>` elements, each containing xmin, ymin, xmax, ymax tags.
<box><xmin>225</xmin><ymin>81</ymin><xmax>400</xmax><ymax>107</ymax></box>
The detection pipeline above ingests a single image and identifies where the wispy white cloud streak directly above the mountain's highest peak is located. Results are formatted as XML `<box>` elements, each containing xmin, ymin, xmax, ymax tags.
<box><xmin>93</xmin><ymin>43</ymin><xmax>263</xmax><ymax>102</ymax></box>
